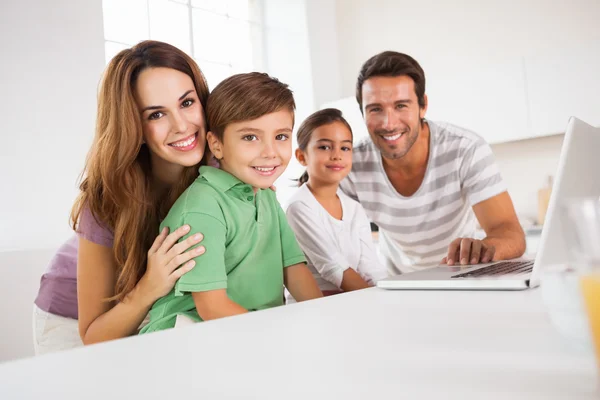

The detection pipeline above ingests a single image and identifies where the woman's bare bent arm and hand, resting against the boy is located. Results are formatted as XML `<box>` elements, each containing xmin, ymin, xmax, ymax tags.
<box><xmin>77</xmin><ymin>227</ymin><xmax>204</xmax><ymax>344</ymax></box>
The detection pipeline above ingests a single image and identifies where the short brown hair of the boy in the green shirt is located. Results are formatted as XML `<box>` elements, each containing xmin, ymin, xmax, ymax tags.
<box><xmin>206</xmin><ymin>72</ymin><xmax>296</xmax><ymax>142</ymax></box>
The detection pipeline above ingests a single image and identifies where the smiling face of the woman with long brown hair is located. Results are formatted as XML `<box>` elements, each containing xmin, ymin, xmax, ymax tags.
<box><xmin>135</xmin><ymin>68</ymin><xmax>206</xmax><ymax>172</ymax></box>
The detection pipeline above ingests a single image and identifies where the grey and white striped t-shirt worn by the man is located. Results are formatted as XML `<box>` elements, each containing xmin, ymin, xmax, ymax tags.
<box><xmin>340</xmin><ymin>120</ymin><xmax>506</xmax><ymax>274</ymax></box>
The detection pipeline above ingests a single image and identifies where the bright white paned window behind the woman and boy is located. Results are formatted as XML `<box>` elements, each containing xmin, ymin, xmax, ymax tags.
<box><xmin>102</xmin><ymin>0</ymin><xmax>263</xmax><ymax>89</ymax></box>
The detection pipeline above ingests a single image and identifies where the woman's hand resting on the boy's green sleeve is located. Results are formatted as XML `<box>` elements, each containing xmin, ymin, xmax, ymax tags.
<box><xmin>138</xmin><ymin>225</ymin><xmax>205</xmax><ymax>304</ymax></box>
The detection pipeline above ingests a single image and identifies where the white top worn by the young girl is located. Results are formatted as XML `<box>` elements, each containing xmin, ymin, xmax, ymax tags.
<box><xmin>286</xmin><ymin>185</ymin><xmax>387</xmax><ymax>300</ymax></box>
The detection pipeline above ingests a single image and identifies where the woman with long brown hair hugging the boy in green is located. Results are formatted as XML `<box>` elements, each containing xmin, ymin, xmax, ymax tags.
<box><xmin>34</xmin><ymin>41</ymin><xmax>208</xmax><ymax>354</ymax></box>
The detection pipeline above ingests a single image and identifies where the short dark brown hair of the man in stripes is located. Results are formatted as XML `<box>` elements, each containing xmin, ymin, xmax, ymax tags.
<box><xmin>356</xmin><ymin>51</ymin><xmax>425</xmax><ymax>112</ymax></box>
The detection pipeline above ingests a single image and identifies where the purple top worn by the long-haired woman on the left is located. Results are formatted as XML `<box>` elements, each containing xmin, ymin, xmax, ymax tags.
<box><xmin>35</xmin><ymin>208</ymin><xmax>114</xmax><ymax>319</ymax></box>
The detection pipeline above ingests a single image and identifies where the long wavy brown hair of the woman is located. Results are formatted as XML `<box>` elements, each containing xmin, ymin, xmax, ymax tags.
<box><xmin>71</xmin><ymin>41</ymin><xmax>208</xmax><ymax>301</ymax></box>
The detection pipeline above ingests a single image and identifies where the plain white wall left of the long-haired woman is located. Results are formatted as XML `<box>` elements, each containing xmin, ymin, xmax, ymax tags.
<box><xmin>0</xmin><ymin>0</ymin><xmax>104</xmax><ymax>250</ymax></box>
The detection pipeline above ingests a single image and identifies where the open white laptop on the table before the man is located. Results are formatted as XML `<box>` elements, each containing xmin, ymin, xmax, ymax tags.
<box><xmin>377</xmin><ymin>117</ymin><xmax>600</xmax><ymax>290</ymax></box>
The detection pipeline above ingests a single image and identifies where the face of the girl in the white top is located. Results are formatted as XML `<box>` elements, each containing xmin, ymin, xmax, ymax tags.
<box><xmin>296</xmin><ymin>121</ymin><xmax>352</xmax><ymax>185</ymax></box>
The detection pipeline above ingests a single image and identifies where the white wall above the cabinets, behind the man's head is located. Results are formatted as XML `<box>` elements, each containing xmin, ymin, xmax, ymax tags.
<box><xmin>336</xmin><ymin>0</ymin><xmax>600</xmax><ymax>101</ymax></box>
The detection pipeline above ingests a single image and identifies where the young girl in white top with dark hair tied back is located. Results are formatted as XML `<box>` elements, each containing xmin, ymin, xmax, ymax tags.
<box><xmin>287</xmin><ymin>108</ymin><xmax>387</xmax><ymax>302</ymax></box>
